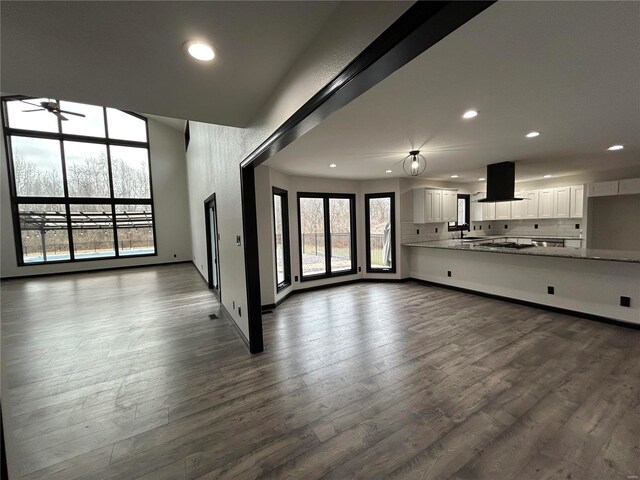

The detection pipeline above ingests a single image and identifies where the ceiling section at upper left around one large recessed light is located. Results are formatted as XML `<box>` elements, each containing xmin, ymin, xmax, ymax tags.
<box><xmin>0</xmin><ymin>1</ymin><xmax>342</xmax><ymax>126</ymax></box>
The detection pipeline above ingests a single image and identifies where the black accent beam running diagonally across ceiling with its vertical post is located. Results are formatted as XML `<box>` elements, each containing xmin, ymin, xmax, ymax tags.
<box><xmin>240</xmin><ymin>1</ymin><xmax>494</xmax><ymax>353</ymax></box>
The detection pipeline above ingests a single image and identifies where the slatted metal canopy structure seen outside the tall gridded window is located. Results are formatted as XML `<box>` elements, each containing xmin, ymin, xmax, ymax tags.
<box><xmin>20</xmin><ymin>211</ymin><xmax>153</xmax><ymax>231</ymax></box>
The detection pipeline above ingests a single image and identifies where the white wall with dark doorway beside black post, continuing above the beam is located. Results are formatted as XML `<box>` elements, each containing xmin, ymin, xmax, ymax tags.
<box><xmin>187</xmin><ymin>2</ymin><xmax>410</xmax><ymax>338</ymax></box>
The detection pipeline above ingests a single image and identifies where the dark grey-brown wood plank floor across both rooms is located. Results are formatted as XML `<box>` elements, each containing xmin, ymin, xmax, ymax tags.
<box><xmin>2</xmin><ymin>264</ymin><xmax>640</xmax><ymax>480</ymax></box>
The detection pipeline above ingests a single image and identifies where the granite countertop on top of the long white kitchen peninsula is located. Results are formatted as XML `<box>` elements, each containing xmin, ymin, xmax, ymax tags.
<box><xmin>402</xmin><ymin>239</ymin><xmax>640</xmax><ymax>263</ymax></box>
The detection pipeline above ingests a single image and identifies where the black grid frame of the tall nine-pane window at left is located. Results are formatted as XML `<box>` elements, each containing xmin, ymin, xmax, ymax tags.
<box><xmin>0</xmin><ymin>95</ymin><xmax>158</xmax><ymax>267</ymax></box>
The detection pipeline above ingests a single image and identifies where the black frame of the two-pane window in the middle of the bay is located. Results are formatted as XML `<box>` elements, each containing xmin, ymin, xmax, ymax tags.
<box><xmin>297</xmin><ymin>192</ymin><xmax>358</xmax><ymax>282</ymax></box>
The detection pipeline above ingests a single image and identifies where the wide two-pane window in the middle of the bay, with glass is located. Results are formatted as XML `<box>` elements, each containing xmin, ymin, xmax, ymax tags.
<box><xmin>298</xmin><ymin>193</ymin><xmax>356</xmax><ymax>281</ymax></box>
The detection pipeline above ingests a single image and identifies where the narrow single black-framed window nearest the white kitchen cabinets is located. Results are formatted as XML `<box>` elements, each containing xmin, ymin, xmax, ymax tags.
<box><xmin>364</xmin><ymin>192</ymin><xmax>396</xmax><ymax>273</ymax></box>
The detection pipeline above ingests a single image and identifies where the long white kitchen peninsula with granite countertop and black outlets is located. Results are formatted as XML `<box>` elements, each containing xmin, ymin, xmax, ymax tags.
<box><xmin>403</xmin><ymin>236</ymin><xmax>640</xmax><ymax>324</ymax></box>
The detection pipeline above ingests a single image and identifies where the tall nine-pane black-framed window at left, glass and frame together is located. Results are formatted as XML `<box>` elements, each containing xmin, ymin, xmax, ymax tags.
<box><xmin>2</xmin><ymin>97</ymin><xmax>156</xmax><ymax>266</ymax></box>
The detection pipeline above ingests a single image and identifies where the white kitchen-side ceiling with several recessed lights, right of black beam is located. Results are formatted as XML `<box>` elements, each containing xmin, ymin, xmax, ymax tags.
<box><xmin>267</xmin><ymin>2</ymin><xmax>640</xmax><ymax>182</ymax></box>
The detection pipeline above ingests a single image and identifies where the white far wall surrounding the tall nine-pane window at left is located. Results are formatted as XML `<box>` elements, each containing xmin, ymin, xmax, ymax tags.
<box><xmin>0</xmin><ymin>119</ymin><xmax>191</xmax><ymax>278</ymax></box>
